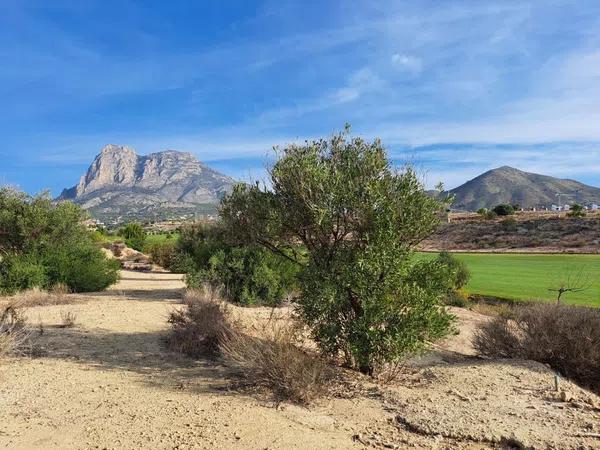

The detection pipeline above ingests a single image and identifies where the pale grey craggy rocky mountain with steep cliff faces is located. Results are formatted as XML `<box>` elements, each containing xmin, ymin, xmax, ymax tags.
<box><xmin>59</xmin><ymin>144</ymin><xmax>235</xmax><ymax>222</ymax></box>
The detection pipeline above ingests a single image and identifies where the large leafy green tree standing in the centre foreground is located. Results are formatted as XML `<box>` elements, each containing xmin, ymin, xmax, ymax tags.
<box><xmin>221</xmin><ymin>130</ymin><xmax>451</xmax><ymax>374</ymax></box>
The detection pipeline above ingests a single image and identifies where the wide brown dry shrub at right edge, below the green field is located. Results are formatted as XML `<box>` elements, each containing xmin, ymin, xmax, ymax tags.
<box><xmin>473</xmin><ymin>303</ymin><xmax>600</xmax><ymax>390</ymax></box>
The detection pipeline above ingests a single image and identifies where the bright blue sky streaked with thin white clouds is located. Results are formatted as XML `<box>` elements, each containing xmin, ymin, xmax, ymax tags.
<box><xmin>0</xmin><ymin>0</ymin><xmax>600</xmax><ymax>194</ymax></box>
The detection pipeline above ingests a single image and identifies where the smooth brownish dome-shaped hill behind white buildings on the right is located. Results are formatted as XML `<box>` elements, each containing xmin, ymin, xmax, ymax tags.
<box><xmin>450</xmin><ymin>166</ymin><xmax>600</xmax><ymax>211</ymax></box>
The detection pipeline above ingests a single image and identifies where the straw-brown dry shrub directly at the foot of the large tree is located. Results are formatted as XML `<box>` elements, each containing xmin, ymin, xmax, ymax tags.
<box><xmin>219</xmin><ymin>320</ymin><xmax>333</xmax><ymax>404</ymax></box>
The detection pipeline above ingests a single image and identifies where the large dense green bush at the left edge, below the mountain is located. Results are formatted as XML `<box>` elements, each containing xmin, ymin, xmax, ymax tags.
<box><xmin>0</xmin><ymin>189</ymin><xmax>118</xmax><ymax>293</ymax></box>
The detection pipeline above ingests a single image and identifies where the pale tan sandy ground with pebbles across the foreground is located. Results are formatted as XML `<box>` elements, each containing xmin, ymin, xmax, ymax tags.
<box><xmin>0</xmin><ymin>272</ymin><xmax>600</xmax><ymax>449</ymax></box>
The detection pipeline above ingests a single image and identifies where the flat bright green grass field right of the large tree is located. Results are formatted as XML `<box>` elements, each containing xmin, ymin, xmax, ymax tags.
<box><xmin>421</xmin><ymin>253</ymin><xmax>600</xmax><ymax>307</ymax></box>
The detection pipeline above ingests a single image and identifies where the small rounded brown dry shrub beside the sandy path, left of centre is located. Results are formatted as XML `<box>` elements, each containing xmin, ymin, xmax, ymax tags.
<box><xmin>167</xmin><ymin>290</ymin><xmax>232</xmax><ymax>358</ymax></box>
